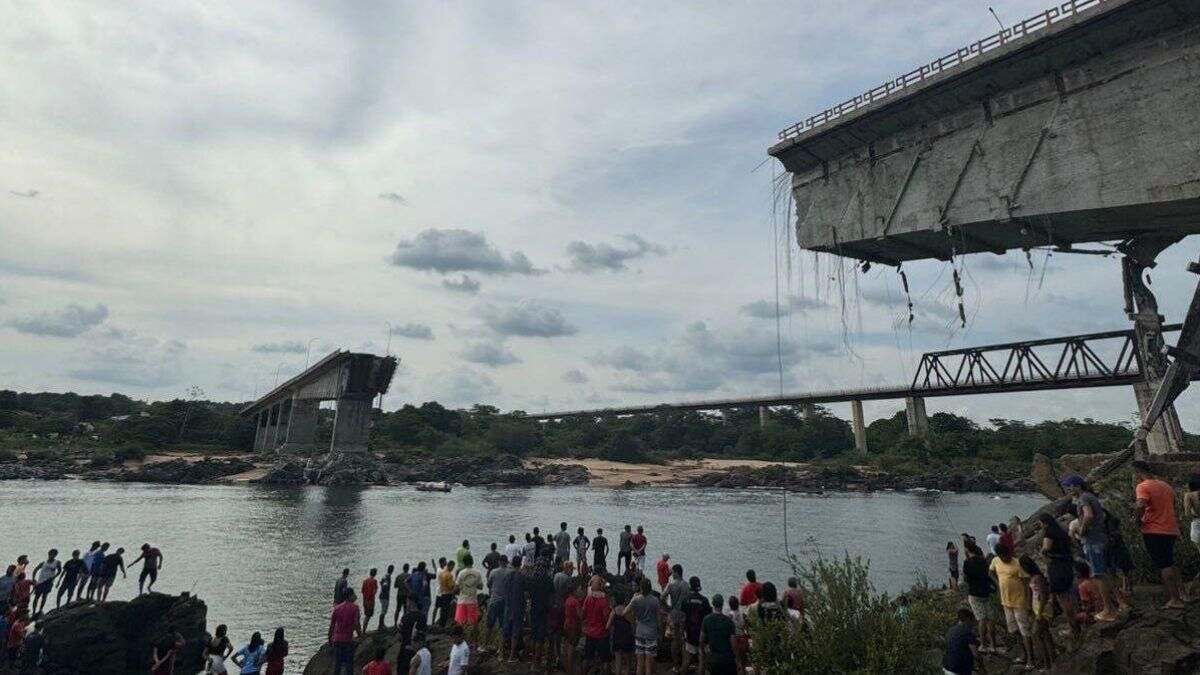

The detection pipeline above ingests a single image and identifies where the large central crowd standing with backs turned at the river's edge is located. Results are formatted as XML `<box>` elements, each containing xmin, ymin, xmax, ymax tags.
<box><xmin>328</xmin><ymin>522</ymin><xmax>804</xmax><ymax>675</ymax></box>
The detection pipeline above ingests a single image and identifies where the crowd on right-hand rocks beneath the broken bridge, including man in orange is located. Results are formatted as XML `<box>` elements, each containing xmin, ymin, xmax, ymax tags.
<box><xmin>942</xmin><ymin>461</ymin><xmax>1200</xmax><ymax>675</ymax></box>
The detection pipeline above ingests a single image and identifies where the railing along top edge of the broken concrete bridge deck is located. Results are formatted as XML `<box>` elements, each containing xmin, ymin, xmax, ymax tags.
<box><xmin>779</xmin><ymin>0</ymin><xmax>1112</xmax><ymax>141</ymax></box>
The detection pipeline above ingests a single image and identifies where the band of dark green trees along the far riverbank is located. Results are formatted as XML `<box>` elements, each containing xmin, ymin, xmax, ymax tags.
<box><xmin>0</xmin><ymin>390</ymin><xmax>1200</xmax><ymax>472</ymax></box>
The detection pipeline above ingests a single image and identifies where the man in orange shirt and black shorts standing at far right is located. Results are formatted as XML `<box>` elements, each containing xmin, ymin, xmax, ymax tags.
<box><xmin>1129</xmin><ymin>460</ymin><xmax>1184</xmax><ymax>609</ymax></box>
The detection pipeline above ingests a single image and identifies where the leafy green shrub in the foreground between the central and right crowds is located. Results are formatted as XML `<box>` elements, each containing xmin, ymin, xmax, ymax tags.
<box><xmin>750</xmin><ymin>555</ymin><xmax>958</xmax><ymax>675</ymax></box>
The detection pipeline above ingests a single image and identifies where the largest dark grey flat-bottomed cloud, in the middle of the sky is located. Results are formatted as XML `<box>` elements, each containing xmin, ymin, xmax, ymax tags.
<box><xmin>391</xmin><ymin>228</ymin><xmax>542</xmax><ymax>276</ymax></box>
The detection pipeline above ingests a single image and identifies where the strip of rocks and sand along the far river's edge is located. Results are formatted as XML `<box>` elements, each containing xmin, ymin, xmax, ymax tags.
<box><xmin>0</xmin><ymin>454</ymin><xmax>1038</xmax><ymax>492</ymax></box>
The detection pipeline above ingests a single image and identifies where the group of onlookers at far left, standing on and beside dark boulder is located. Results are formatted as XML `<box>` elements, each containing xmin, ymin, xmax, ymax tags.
<box><xmin>0</xmin><ymin>542</ymin><xmax>163</xmax><ymax>668</ymax></box>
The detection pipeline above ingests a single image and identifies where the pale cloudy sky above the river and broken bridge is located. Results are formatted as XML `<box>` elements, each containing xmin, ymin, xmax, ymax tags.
<box><xmin>0</xmin><ymin>0</ymin><xmax>1198</xmax><ymax>430</ymax></box>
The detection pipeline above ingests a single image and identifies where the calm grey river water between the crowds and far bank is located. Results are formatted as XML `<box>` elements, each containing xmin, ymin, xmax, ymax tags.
<box><xmin>0</xmin><ymin>480</ymin><xmax>1044</xmax><ymax>673</ymax></box>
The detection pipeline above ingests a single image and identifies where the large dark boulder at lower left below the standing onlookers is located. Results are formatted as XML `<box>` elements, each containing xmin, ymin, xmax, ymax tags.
<box><xmin>38</xmin><ymin>593</ymin><xmax>208</xmax><ymax>675</ymax></box>
